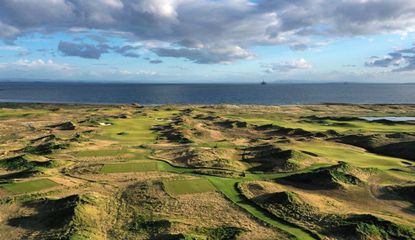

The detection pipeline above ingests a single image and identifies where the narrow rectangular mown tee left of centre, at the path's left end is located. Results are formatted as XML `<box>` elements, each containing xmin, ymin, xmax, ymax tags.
<box><xmin>101</xmin><ymin>162</ymin><xmax>158</xmax><ymax>173</ymax></box>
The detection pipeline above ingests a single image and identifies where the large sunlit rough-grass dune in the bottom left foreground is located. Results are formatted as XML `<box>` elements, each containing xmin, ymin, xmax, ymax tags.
<box><xmin>9</xmin><ymin>193</ymin><xmax>109</xmax><ymax>240</ymax></box>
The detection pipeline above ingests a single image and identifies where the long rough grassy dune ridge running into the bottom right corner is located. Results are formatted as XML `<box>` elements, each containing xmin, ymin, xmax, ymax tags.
<box><xmin>238</xmin><ymin>182</ymin><xmax>415</xmax><ymax>240</ymax></box>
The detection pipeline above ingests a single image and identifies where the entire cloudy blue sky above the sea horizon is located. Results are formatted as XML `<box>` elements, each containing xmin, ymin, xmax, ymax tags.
<box><xmin>0</xmin><ymin>0</ymin><xmax>415</xmax><ymax>83</ymax></box>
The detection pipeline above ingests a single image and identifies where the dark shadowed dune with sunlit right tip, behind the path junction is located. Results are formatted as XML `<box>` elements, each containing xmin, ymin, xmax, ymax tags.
<box><xmin>243</xmin><ymin>144</ymin><xmax>312</xmax><ymax>172</ymax></box>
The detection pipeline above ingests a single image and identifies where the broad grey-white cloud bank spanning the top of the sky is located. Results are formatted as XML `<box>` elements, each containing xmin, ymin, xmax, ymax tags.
<box><xmin>0</xmin><ymin>0</ymin><xmax>415</xmax><ymax>63</ymax></box>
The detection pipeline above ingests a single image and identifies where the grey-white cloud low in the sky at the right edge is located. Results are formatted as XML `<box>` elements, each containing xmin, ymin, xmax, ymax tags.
<box><xmin>365</xmin><ymin>47</ymin><xmax>415</xmax><ymax>72</ymax></box>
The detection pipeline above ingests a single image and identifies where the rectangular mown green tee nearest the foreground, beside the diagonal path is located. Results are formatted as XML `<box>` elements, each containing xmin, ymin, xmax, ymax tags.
<box><xmin>163</xmin><ymin>179</ymin><xmax>216</xmax><ymax>195</ymax></box>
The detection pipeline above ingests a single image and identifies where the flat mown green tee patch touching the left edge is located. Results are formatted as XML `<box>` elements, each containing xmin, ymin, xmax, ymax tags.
<box><xmin>1</xmin><ymin>179</ymin><xmax>59</xmax><ymax>194</ymax></box>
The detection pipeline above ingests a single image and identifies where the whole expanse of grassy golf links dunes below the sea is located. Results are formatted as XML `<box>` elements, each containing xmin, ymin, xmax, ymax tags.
<box><xmin>0</xmin><ymin>103</ymin><xmax>415</xmax><ymax>240</ymax></box>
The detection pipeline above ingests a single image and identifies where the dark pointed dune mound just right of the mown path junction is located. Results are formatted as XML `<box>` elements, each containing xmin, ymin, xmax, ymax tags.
<box><xmin>282</xmin><ymin>163</ymin><xmax>362</xmax><ymax>189</ymax></box>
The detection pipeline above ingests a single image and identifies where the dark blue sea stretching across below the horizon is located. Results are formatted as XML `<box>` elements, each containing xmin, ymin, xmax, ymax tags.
<box><xmin>0</xmin><ymin>82</ymin><xmax>415</xmax><ymax>105</ymax></box>
